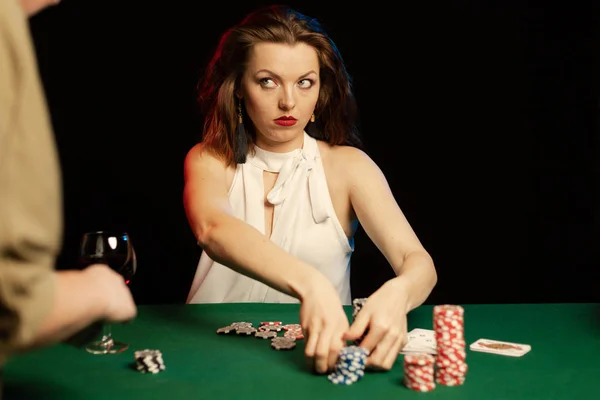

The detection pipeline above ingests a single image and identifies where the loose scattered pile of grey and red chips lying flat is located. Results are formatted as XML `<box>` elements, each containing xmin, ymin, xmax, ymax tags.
<box><xmin>217</xmin><ymin>321</ymin><xmax>304</xmax><ymax>350</ymax></box>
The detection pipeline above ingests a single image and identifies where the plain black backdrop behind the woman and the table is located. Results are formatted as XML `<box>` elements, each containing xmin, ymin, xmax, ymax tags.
<box><xmin>25</xmin><ymin>0</ymin><xmax>600</xmax><ymax>304</ymax></box>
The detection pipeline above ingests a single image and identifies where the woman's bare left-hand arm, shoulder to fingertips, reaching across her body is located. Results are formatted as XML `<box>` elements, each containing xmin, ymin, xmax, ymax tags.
<box><xmin>184</xmin><ymin>145</ymin><xmax>348</xmax><ymax>373</ymax></box>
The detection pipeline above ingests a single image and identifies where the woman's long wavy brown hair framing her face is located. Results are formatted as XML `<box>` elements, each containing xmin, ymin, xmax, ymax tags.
<box><xmin>198</xmin><ymin>5</ymin><xmax>362</xmax><ymax>165</ymax></box>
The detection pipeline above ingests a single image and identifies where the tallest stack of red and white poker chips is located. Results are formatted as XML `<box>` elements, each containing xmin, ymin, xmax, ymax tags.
<box><xmin>433</xmin><ymin>305</ymin><xmax>467</xmax><ymax>386</ymax></box>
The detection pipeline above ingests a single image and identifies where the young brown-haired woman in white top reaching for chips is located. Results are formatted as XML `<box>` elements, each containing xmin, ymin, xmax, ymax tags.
<box><xmin>184</xmin><ymin>6</ymin><xmax>437</xmax><ymax>373</ymax></box>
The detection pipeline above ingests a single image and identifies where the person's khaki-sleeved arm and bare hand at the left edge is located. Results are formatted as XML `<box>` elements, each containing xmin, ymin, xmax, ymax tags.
<box><xmin>0</xmin><ymin>0</ymin><xmax>136</xmax><ymax>355</ymax></box>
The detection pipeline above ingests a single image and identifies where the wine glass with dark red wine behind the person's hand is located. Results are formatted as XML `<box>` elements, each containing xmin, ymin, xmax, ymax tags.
<box><xmin>79</xmin><ymin>231</ymin><xmax>137</xmax><ymax>354</ymax></box>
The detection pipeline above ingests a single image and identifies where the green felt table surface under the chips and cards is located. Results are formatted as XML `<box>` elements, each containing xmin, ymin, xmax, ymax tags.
<box><xmin>4</xmin><ymin>304</ymin><xmax>600</xmax><ymax>400</ymax></box>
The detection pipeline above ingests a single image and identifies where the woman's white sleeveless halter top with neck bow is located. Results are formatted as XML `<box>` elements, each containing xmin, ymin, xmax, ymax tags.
<box><xmin>187</xmin><ymin>132</ymin><xmax>354</xmax><ymax>305</ymax></box>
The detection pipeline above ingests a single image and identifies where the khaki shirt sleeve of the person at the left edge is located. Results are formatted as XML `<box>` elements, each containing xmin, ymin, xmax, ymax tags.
<box><xmin>0</xmin><ymin>0</ymin><xmax>62</xmax><ymax>356</ymax></box>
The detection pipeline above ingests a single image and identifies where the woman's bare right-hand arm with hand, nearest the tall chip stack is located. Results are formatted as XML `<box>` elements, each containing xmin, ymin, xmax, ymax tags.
<box><xmin>344</xmin><ymin>148</ymin><xmax>437</xmax><ymax>370</ymax></box>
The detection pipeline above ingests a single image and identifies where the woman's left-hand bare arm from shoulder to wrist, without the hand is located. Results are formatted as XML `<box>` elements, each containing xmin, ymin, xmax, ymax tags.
<box><xmin>183</xmin><ymin>144</ymin><xmax>326</xmax><ymax>299</ymax></box>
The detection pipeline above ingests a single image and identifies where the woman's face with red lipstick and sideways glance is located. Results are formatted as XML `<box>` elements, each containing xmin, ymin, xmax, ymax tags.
<box><xmin>239</xmin><ymin>43</ymin><xmax>320</xmax><ymax>152</ymax></box>
